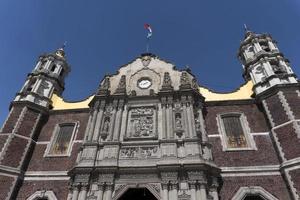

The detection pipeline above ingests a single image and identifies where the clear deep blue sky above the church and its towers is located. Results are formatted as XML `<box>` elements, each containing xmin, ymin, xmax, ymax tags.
<box><xmin>0</xmin><ymin>0</ymin><xmax>300</xmax><ymax>126</ymax></box>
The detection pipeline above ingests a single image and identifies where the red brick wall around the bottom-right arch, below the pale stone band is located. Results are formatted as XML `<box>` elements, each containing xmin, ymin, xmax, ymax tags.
<box><xmin>220</xmin><ymin>176</ymin><xmax>290</xmax><ymax>200</ymax></box>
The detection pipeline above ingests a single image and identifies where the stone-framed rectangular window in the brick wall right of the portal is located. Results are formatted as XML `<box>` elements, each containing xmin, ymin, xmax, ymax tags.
<box><xmin>218</xmin><ymin>113</ymin><xmax>256</xmax><ymax>150</ymax></box>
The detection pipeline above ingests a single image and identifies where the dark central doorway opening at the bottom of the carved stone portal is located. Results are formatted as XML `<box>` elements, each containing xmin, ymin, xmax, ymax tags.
<box><xmin>118</xmin><ymin>188</ymin><xmax>157</xmax><ymax>200</ymax></box>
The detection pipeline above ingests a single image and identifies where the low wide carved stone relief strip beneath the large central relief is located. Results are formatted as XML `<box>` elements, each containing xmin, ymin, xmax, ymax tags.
<box><xmin>120</xmin><ymin>146</ymin><xmax>159</xmax><ymax>159</ymax></box>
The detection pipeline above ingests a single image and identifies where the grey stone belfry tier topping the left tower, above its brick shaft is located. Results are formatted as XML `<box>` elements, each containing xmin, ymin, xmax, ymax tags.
<box><xmin>14</xmin><ymin>46</ymin><xmax>70</xmax><ymax>108</ymax></box>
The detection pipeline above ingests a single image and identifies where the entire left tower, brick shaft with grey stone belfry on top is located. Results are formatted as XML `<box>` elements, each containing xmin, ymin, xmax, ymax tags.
<box><xmin>0</xmin><ymin>45</ymin><xmax>70</xmax><ymax>199</ymax></box>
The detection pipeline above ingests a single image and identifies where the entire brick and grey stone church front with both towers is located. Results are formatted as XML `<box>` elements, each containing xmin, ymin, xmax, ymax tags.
<box><xmin>0</xmin><ymin>31</ymin><xmax>300</xmax><ymax>200</ymax></box>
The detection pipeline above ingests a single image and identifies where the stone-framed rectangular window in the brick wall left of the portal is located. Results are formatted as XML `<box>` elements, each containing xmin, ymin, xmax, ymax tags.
<box><xmin>47</xmin><ymin>123</ymin><xmax>76</xmax><ymax>156</ymax></box>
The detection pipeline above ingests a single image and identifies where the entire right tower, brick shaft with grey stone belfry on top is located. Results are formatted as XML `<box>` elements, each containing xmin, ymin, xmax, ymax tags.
<box><xmin>238</xmin><ymin>29</ymin><xmax>300</xmax><ymax>199</ymax></box>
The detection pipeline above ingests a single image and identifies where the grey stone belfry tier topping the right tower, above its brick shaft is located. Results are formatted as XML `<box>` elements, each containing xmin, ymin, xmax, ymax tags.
<box><xmin>238</xmin><ymin>27</ymin><xmax>297</xmax><ymax>94</ymax></box>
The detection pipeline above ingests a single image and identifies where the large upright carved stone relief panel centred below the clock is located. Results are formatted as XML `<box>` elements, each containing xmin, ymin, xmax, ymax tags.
<box><xmin>129</xmin><ymin>107</ymin><xmax>155</xmax><ymax>138</ymax></box>
